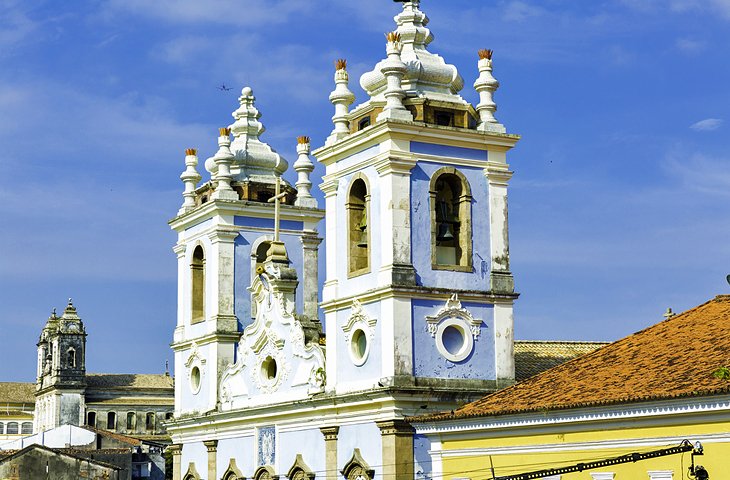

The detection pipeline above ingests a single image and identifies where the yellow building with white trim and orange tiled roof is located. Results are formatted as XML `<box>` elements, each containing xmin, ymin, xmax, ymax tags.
<box><xmin>411</xmin><ymin>296</ymin><xmax>730</xmax><ymax>480</ymax></box>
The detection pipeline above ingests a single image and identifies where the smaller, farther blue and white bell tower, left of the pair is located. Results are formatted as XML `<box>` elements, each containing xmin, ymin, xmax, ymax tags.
<box><xmin>170</xmin><ymin>87</ymin><xmax>324</xmax><ymax>415</ymax></box>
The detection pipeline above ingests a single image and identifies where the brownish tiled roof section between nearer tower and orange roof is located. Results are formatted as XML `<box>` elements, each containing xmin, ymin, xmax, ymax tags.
<box><xmin>515</xmin><ymin>340</ymin><xmax>608</xmax><ymax>382</ymax></box>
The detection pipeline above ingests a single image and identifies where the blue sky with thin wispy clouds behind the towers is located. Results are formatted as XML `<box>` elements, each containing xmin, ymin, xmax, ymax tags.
<box><xmin>0</xmin><ymin>0</ymin><xmax>730</xmax><ymax>381</ymax></box>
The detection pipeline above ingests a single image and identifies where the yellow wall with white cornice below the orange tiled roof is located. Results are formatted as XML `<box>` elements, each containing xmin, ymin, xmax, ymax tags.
<box><xmin>416</xmin><ymin>406</ymin><xmax>730</xmax><ymax>480</ymax></box>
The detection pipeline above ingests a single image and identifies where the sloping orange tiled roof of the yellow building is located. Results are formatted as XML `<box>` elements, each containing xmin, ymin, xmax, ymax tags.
<box><xmin>418</xmin><ymin>295</ymin><xmax>730</xmax><ymax>421</ymax></box>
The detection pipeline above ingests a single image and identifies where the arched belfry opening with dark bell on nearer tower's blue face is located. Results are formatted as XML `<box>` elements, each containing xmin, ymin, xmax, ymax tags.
<box><xmin>430</xmin><ymin>167</ymin><xmax>472</xmax><ymax>271</ymax></box>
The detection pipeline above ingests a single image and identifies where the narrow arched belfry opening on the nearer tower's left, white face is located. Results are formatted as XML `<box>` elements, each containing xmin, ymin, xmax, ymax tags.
<box><xmin>345</xmin><ymin>174</ymin><xmax>371</xmax><ymax>276</ymax></box>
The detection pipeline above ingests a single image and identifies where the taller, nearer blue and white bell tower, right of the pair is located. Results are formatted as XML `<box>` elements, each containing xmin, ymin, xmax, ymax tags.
<box><xmin>314</xmin><ymin>0</ymin><xmax>519</xmax><ymax>393</ymax></box>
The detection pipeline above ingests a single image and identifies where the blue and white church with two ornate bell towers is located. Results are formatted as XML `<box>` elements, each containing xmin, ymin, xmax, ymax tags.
<box><xmin>168</xmin><ymin>0</ymin><xmax>519</xmax><ymax>480</ymax></box>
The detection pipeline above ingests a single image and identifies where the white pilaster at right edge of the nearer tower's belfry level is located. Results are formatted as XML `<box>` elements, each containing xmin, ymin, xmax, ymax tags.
<box><xmin>484</xmin><ymin>150</ymin><xmax>515</xmax><ymax>294</ymax></box>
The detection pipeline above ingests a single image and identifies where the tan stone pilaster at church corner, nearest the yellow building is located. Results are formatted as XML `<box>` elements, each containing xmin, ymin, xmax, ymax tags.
<box><xmin>376</xmin><ymin>420</ymin><xmax>414</xmax><ymax>480</ymax></box>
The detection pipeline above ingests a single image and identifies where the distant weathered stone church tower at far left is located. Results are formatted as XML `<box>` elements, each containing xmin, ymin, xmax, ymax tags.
<box><xmin>34</xmin><ymin>299</ymin><xmax>86</xmax><ymax>432</ymax></box>
